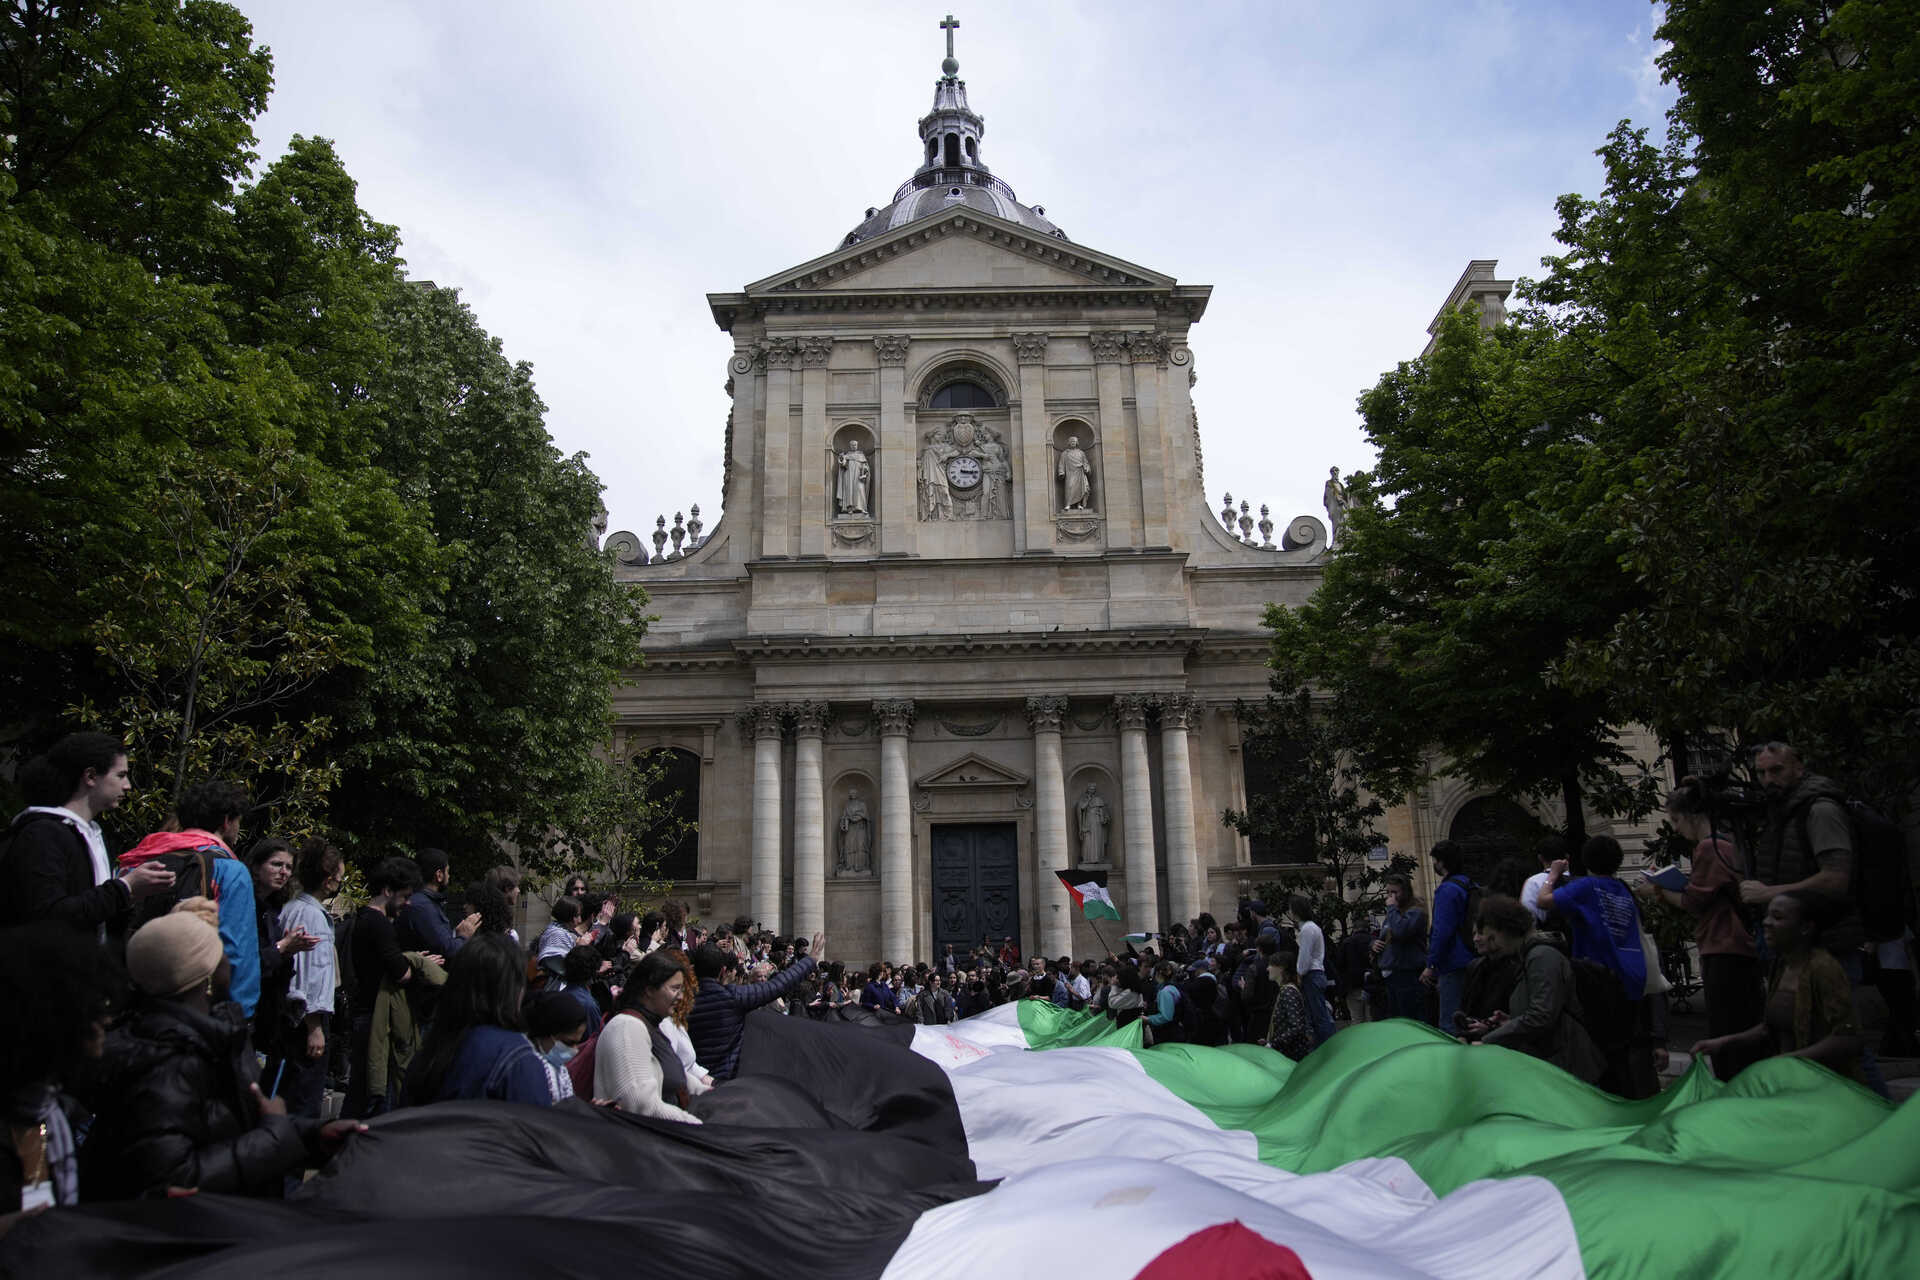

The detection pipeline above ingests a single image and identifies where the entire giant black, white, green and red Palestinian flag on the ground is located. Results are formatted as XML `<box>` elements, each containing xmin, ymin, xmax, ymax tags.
<box><xmin>0</xmin><ymin>1000</ymin><xmax>1920</xmax><ymax>1280</ymax></box>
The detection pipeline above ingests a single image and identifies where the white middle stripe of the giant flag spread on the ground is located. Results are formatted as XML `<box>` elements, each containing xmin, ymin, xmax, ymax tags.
<box><xmin>902</xmin><ymin>1004</ymin><xmax>1584</xmax><ymax>1280</ymax></box>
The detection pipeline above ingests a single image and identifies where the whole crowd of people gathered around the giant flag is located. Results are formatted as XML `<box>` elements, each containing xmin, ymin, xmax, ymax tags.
<box><xmin>0</xmin><ymin>733</ymin><xmax>1912</xmax><ymax>1213</ymax></box>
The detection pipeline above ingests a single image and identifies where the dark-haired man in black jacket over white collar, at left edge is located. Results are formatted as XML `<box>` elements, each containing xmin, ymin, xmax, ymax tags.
<box><xmin>0</xmin><ymin>733</ymin><xmax>173</xmax><ymax>940</ymax></box>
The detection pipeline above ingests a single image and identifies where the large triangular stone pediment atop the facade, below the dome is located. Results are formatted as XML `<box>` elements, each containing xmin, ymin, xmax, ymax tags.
<box><xmin>747</xmin><ymin>209</ymin><xmax>1175</xmax><ymax>297</ymax></box>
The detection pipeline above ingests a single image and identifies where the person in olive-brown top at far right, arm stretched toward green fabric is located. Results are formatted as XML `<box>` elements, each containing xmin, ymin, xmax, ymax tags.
<box><xmin>1693</xmin><ymin>890</ymin><xmax>1866</xmax><ymax>1084</ymax></box>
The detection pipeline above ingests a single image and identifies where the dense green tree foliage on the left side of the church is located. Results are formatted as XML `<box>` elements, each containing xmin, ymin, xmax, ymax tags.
<box><xmin>0</xmin><ymin>0</ymin><xmax>645</xmax><ymax>860</ymax></box>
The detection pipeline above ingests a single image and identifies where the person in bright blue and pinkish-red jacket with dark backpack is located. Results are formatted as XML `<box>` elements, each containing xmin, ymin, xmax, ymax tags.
<box><xmin>121</xmin><ymin>779</ymin><xmax>259</xmax><ymax>1017</ymax></box>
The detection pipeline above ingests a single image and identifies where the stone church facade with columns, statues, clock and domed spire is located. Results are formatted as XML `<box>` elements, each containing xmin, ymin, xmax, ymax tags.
<box><xmin>607</xmin><ymin>32</ymin><xmax>1666</xmax><ymax>961</ymax></box>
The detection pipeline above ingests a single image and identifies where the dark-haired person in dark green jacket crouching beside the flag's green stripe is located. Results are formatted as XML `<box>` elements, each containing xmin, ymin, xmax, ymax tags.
<box><xmin>1465</xmin><ymin>894</ymin><xmax>1605</xmax><ymax>1084</ymax></box>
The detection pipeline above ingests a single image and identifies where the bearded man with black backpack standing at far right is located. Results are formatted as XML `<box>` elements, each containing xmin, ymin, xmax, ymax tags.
<box><xmin>1740</xmin><ymin>743</ymin><xmax>1907</xmax><ymax>1098</ymax></box>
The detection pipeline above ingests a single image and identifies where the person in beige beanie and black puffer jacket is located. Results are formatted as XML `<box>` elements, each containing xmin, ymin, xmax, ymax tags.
<box><xmin>81</xmin><ymin>898</ymin><xmax>365</xmax><ymax>1199</ymax></box>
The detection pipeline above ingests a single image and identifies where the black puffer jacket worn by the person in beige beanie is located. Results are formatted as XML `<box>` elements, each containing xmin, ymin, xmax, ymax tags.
<box><xmin>81</xmin><ymin>1000</ymin><xmax>319</xmax><ymax>1199</ymax></box>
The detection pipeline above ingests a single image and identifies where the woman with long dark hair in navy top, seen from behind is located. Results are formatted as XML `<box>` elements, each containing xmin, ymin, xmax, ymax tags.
<box><xmin>407</xmin><ymin>933</ymin><xmax>553</xmax><ymax>1107</ymax></box>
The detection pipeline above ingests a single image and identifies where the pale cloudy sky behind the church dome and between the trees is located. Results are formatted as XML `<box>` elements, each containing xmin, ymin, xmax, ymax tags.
<box><xmin>238</xmin><ymin>0</ymin><xmax>1672</xmax><ymax>535</ymax></box>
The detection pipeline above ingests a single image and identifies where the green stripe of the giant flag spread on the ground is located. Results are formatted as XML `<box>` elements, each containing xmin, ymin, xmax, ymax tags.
<box><xmin>1021</xmin><ymin>1009</ymin><xmax>1920</xmax><ymax>1278</ymax></box>
